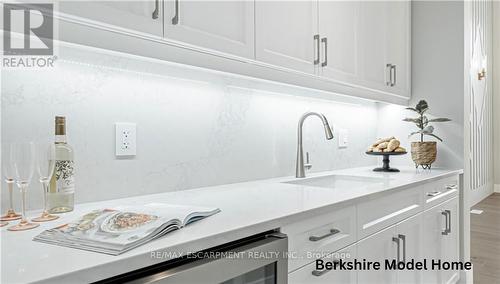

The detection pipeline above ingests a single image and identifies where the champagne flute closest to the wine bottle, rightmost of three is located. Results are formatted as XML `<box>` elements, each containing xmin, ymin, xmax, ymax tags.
<box><xmin>31</xmin><ymin>143</ymin><xmax>59</xmax><ymax>222</ymax></box>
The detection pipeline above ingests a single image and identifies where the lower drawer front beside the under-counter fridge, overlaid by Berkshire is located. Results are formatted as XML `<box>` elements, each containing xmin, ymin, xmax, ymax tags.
<box><xmin>288</xmin><ymin>245</ymin><xmax>357</xmax><ymax>284</ymax></box>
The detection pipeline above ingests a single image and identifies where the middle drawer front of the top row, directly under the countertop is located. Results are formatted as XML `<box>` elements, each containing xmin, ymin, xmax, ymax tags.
<box><xmin>357</xmin><ymin>186</ymin><xmax>423</xmax><ymax>239</ymax></box>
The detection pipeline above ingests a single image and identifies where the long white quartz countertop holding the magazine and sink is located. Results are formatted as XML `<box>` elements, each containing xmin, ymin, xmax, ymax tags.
<box><xmin>0</xmin><ymin>167</ymin><xmax>462</xmax><ymax>283</ymax></box>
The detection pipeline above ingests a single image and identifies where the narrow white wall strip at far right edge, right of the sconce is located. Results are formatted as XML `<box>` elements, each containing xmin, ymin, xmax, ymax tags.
<box><xmin>493</xmin><ymin>1</ymin><xmax>500</xmax><ymax>192</ymax></box>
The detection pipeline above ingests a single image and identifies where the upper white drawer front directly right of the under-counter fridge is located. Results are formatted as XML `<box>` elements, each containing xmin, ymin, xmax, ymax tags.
<box><xmin>281</xmin><ymin>206</ymin><xmax>356</xmax><ymax>271</ymax></box>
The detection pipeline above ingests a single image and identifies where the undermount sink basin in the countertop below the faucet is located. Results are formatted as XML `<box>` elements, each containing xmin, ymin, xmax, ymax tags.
<box><xmin>284</xmin><ymin>175</ymin><xmax>387</xmax><ymax>188</ymax></box>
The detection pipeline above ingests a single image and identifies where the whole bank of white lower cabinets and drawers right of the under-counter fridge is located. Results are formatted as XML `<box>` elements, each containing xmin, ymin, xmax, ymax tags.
<box><xmin>283</xmin><ymin>176</ymin><xmax>460</xmax><ymax>284</ymax></box>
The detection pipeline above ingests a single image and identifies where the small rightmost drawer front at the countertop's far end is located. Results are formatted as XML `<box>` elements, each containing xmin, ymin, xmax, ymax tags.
<box><xmin>424</xmin><ymin>176</ymin><xmax>460</xmax><ymax>209</ymax></box>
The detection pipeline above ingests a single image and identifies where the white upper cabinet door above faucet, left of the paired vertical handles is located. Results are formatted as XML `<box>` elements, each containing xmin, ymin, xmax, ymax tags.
<box><xmin>255</xmin><ymin>0</ymin><xmax>319</xmax><ymax>74</ymax></box>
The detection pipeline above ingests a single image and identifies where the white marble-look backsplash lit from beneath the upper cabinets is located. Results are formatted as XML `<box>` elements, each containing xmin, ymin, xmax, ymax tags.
<box><xmin>1</xmin><ymin>42</ymin><xmax>378</xmax><ymax>211</ymax></box>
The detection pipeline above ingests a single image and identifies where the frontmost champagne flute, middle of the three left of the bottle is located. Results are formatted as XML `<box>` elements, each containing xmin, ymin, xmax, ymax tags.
<box><xmin>7</xmin><ymin>142</ymin><xmax>40</xmax><ymax>231</ymax></box>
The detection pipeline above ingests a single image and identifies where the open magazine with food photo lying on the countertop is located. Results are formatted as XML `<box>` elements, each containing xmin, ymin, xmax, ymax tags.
<box><xmin>33</xmin><ymin>203</ymin><xmax>220</xmax><ymax>255</ymax></box>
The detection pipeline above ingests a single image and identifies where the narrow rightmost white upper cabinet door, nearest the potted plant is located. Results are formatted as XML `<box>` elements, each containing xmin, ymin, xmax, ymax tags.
<box><xmin>386</xmin><ymin>1</ymin><xmax>411</xmax><ymax>98</ymax></box>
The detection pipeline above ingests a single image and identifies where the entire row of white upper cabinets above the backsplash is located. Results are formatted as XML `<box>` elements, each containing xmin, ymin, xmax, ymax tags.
<box><xmin>55</xmin><ymin>0</ymin><xmax>411</xmax><ymax>104</ymax></box>
